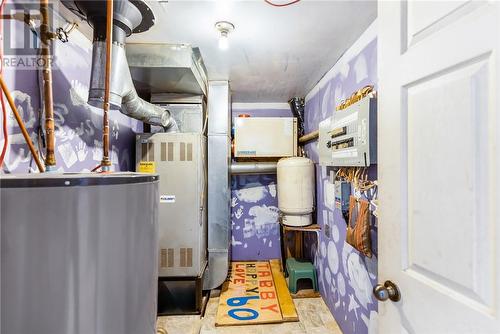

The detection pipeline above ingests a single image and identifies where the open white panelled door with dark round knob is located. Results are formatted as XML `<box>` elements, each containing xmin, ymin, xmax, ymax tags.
<box><xmin>378</xmin><ymin>1</ymin><xmax>500</xmax><ymax>334</ymax></box>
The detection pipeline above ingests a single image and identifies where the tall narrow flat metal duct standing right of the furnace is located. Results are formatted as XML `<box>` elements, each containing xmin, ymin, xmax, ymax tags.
<box><xmin>203</xmin><ymin>81</ymin><xmax>231</xmax><ymax>290</ymax></box>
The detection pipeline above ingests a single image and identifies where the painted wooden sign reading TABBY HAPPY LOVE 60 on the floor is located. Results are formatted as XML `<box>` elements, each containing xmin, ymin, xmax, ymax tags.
<box><xmin>215</xmin><ymin>261</ymin><xmax>298</xmax><ymax>326</ymax></box>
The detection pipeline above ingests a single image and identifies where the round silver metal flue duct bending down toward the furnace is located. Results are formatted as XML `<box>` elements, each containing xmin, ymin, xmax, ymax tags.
<box><xmin>62</xmin><ymin>0</ymin><xmax>177</xmax><ymax>132</ymax></box>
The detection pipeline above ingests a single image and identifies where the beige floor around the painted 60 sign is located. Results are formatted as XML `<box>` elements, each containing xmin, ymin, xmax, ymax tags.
<box><xmin>158</xmin><ymin>297</ymin><xmax>342</xmax><ymax>334</ymax></box>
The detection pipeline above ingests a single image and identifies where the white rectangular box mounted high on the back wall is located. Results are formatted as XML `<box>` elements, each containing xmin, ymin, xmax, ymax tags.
<box><xmin>234</xmin><ymin>117</ymin><xmax>297</xmax><ymax>158</ymax></box>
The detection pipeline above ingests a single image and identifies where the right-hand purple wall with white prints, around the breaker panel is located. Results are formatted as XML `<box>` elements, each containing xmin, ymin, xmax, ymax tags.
<box><xmin>305</xmin><ymin>33</ymin><xmax>378</xmax><ymax>334</ymax></box>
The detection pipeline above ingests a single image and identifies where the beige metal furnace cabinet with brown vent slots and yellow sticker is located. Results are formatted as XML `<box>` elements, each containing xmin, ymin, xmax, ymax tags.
<box><xmin>136</xmin><ymin>133</ymin><xmax>207</xmax><ymax>277</ymax></box>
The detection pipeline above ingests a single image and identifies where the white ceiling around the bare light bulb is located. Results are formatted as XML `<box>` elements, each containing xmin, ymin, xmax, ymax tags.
<box><xmin>129</xmin><ymin>0</ymin><xmax>377</xmax><ymax>102</ymax></box>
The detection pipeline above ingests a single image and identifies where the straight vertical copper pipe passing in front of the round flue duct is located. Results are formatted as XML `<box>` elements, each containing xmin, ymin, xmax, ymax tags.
<box><xmin>101</xmin><ymin>0</ymin><xmax>113</xmax><ymax>171</ymax></box>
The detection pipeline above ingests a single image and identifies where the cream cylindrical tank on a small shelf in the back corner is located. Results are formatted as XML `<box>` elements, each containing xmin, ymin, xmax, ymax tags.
<box><xmin>277</xmin><ymin>157</ymin><xmax>314</xmax><ymax>226</ymax></box>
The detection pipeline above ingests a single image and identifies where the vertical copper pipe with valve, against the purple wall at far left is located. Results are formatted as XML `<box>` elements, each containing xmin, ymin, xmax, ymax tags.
<box><xmin>40</xmin><ymin>0</ymin><xmax>56</xmax><ymax>170</ymax></box>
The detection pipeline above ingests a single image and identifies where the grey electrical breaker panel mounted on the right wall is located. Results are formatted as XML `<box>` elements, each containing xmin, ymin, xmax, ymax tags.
<box><xmin>318</xmin><ymin>97</ymin><xmax>377</xmax><ymax>167</ymax></box>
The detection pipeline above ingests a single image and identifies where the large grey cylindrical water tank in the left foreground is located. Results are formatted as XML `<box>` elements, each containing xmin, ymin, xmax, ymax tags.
<box><xmin>0</xmin><ymin>173</ymin><xmax>159</xmax><ymax>334</ymax></box>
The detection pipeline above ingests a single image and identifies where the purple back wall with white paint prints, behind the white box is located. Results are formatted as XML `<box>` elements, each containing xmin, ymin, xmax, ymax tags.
<box><xmin>231</xmin><ymin>109</ymin><xmax>292</xmax><ymax>261</ymax></box>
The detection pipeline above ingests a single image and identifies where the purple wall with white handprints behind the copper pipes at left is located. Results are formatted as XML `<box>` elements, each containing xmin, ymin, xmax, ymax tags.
<box><xmin>0</xmin><ymin>23</ymin><xmax>142</xmax><ymax>173</ymax></box>
